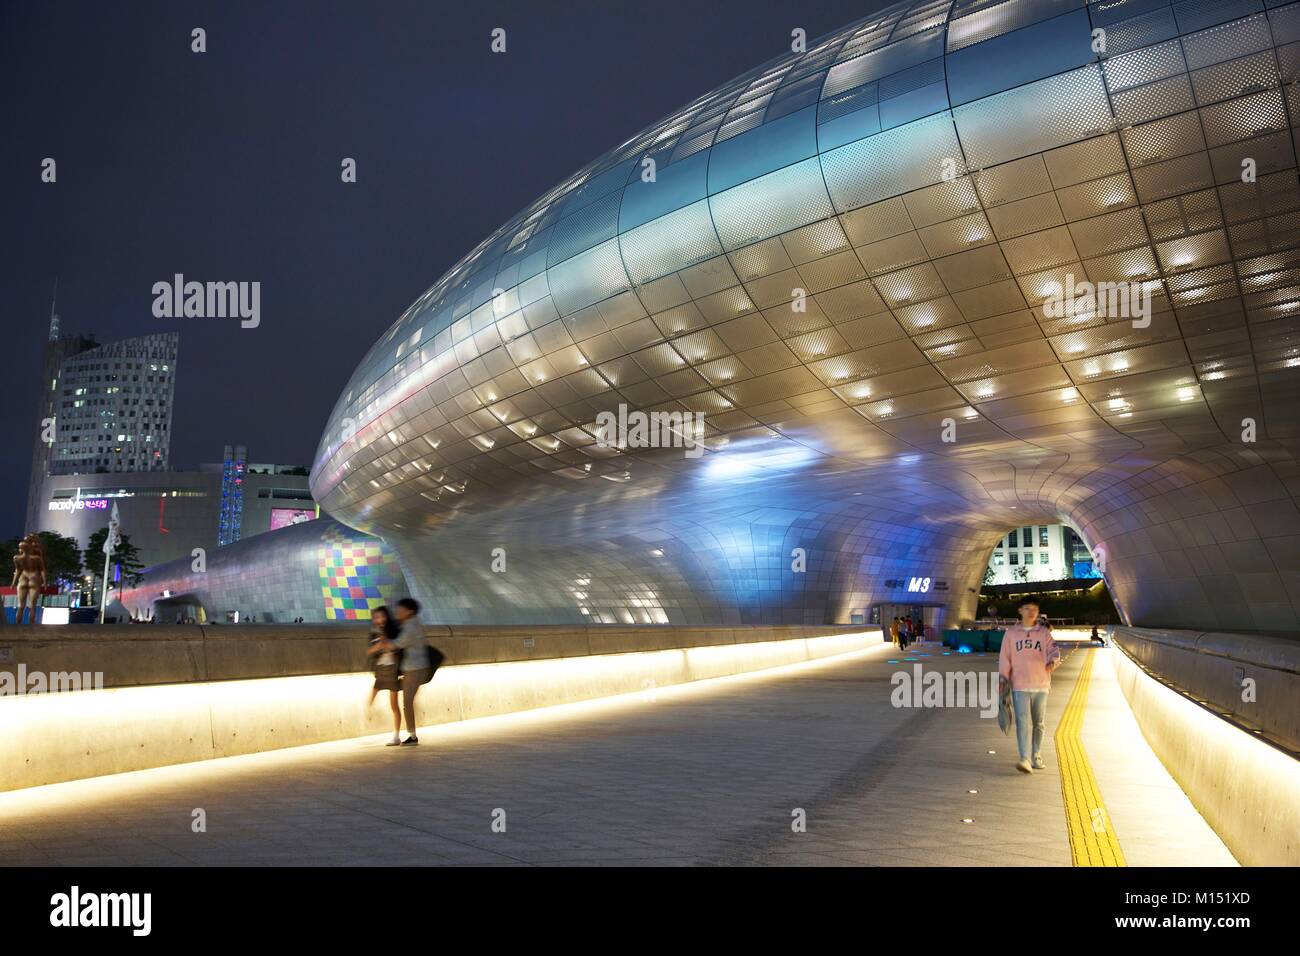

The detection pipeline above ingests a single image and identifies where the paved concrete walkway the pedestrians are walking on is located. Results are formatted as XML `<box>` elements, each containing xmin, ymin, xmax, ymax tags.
<box><xmin>0</xmin><ymin>646</ymin><xmax>1231</xmax><ymax>866</ymax></box>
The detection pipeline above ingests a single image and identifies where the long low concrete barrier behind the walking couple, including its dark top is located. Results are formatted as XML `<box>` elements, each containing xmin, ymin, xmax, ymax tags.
<box><xmin>0</xmin><ymin>626</ymin><xmax>880</xmax><ymax>790</ymax></box>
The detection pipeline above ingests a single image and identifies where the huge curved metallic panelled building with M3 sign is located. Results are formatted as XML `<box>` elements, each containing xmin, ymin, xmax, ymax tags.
<box><xmin>312</xmin><ymin>0</ymin><xmax>1300</xmax><ymax>631</ymax></box>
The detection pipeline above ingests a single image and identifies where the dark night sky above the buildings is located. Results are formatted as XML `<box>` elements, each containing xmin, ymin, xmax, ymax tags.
<box><xmin>0</xmin><ymin>0</ymin><xmax>884</xmax><ymax>537</ymax></box>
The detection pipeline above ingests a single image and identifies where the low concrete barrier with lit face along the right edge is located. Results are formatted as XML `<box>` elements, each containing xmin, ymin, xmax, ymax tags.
<box><xmin>1112</xmin><ymin>627</ymin><xmax>1300</xmax><ymax>866</ymax></box>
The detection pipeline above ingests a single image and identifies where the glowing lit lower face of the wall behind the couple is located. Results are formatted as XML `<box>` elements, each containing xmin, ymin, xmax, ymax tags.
<box><xmin>0</xmin><ymin>631</ymin><xmax>888</xmax><ymax>796</ymax></box>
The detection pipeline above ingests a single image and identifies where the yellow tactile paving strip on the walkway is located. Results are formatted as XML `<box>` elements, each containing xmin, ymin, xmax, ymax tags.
<box><xmin>1056</xmin><ymin>653</ymin><xmax>1127</xmax><ymax>866</ymax></box>
